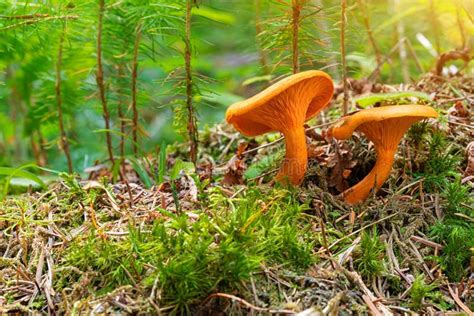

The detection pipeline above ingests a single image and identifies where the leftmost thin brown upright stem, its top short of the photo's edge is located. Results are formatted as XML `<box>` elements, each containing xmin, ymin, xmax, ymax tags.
<box><xmin>55</xmin><ymin>26</ymin><xmax>74</xmax><ymax>173</ymax></box>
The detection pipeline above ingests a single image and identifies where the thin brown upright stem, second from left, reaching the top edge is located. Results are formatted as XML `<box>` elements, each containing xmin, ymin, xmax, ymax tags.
<box><xmin>96</xmin><ymin>0</ymin><xmax>115</xmax><ymax>164</ymax></box>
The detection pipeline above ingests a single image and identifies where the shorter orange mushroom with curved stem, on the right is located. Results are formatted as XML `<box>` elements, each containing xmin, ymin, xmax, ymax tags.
<box><xmin>330</xmin><ymin>105</ymin><xmax>438</xmax><ymax>204</ymax></box>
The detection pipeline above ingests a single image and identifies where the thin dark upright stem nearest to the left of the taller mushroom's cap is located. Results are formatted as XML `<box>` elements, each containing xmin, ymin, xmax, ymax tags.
<box><xmin>184</xmin><ymin>0</ymin><xmax>198</xmax><ymax>164</ymax></box>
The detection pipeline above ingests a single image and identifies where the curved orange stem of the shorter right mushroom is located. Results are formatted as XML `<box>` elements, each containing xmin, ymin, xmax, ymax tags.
<box><xmin>342</xmin><ymin>149</ymin><xmax>395</xmax><ymax>204</ymax></box>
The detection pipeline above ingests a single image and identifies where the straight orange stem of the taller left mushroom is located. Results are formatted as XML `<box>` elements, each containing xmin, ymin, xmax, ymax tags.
<box><xmin>275</xmin><ymin>125</ymin><xmax>308</xmax><ymax>185</ymax></box>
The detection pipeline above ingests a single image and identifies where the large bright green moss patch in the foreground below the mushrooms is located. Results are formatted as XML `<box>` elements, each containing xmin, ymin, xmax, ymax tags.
<box><xmin>59</xmin><ymin>189</ymin><xmax>314</xmax><ymax>311</ymax></box>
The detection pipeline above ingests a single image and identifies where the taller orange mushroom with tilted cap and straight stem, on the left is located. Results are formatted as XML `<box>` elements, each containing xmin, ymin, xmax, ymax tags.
<box><xmin>226</xmin><ymin>70</ymin><xmax>334</xmax><ymax>185</ymax></box>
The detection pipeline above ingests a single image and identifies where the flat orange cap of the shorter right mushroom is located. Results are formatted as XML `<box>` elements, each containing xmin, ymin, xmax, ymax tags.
<box><xmin>331</xmin><ymin>104</ymin><xmax>438</xmax><ymax>139</ymax></box>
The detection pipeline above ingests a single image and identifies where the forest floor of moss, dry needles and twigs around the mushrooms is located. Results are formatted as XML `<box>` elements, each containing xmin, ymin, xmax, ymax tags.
<box><xmin>0</xmin><ymin>70</ymin><xmax>474</xmax><ymax>315</ymax></box>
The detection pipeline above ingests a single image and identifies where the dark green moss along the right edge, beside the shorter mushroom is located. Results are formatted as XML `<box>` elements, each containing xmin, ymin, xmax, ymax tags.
<box><xmin>412</xmin><ymin>132</ymin><xmax>474</xmax><ymax>281</ymax></box>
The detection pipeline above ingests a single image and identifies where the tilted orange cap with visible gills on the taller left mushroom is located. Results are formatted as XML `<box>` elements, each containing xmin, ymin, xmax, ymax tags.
<box><xmin>226</xmin><ymin>70</ymin><xmax>334</xmax><ymax>136</ymax></box>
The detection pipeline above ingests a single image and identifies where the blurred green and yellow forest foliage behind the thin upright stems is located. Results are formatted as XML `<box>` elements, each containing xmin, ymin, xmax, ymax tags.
<box><xmin>0</xmin><ymin>0</ymin><xmax>473</xmax><ymax>171</ymax></box>
